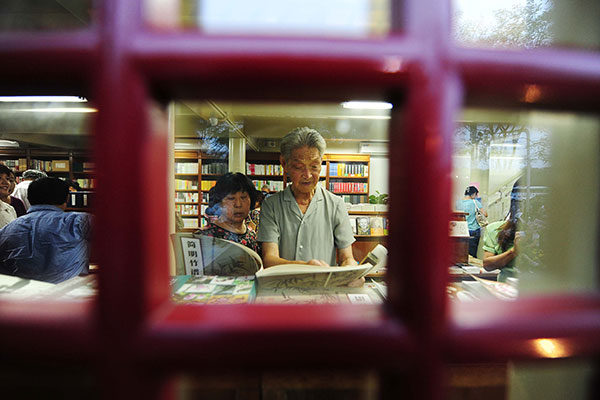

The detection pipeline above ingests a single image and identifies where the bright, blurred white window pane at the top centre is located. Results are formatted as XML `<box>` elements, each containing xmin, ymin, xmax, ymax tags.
<box><xmin>145</xmin><ymin>0</ymin><xmax>390</xmax><ymax>38</ymax></box>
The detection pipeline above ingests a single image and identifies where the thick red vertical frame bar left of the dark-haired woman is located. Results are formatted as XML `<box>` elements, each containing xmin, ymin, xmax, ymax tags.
<box><xmin>94</xmin><ymin>0</ymin><xmax>168</xmax><ymax>398</ymax></box>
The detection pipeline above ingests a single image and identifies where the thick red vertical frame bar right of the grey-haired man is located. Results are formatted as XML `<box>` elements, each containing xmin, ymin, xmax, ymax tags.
<box><xmin>388</xmin><ymin>0</ymin><xmax>454</xmax><ymax>399</ymax></box>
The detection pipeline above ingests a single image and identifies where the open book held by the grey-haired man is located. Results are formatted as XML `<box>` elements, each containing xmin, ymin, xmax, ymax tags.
<box><xmin>256</xmin><ymin>264</ymin><xmax>374</xmax><ymax>289</ymax></box>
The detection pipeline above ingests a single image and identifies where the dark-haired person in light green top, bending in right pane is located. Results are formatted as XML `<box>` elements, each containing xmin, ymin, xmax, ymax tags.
<box><xmin>483</xmin><ymin>181</ymin><xmax>521</xmax><ymax>282</ymax></box>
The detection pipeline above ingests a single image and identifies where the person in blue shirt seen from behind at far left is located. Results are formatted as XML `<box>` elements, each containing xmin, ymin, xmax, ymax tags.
<box><xmin>0</xmin><ymin>178</ymin><xmax>91</xmax><ymax>283</ymax></box>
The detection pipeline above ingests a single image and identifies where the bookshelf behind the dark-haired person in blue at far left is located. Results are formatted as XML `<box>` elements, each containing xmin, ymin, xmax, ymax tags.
<box><xmin>0</xmin><ymin>147</ymin><xmax>96</xmax><ymax>211</ymax></box>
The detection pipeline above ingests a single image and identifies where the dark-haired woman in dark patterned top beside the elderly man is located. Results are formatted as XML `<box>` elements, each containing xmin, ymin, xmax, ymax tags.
<box><xmin>195</xmin><ymin>172</ymin><xmax>260</xmax><ymax>254</ymax></box>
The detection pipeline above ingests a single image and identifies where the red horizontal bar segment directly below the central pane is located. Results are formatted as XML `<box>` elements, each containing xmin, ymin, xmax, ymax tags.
<box><xmin>136</xmin><ymin>303</ymin><xmax>415</xmax><ymax>369</ymax></box>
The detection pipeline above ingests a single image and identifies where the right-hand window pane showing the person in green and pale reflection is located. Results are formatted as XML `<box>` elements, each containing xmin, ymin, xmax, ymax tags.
<box><xmin>448</xmin><ymin>109</ymin><xmax>600</xmax><ymax>300</ymax></box>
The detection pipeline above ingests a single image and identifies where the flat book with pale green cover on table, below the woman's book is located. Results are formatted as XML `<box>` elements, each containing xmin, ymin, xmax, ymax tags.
<box><xmin>171</xmin><ymin>275</ymin><xmax>256</xmax><ymax>304</ymax></box>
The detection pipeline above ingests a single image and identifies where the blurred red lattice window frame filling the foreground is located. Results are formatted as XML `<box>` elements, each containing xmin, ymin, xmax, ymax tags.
<box><xmin>0</xmin><ymin>0</ymin><xmax>600</xmax><ymax>398</ymax></box>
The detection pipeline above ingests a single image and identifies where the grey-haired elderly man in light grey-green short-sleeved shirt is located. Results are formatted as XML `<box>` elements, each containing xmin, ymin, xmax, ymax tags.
<box><xmin>258</xmin><ymin>127</ymin><xmax>356</xmax><ymax>272</ymax></box>
